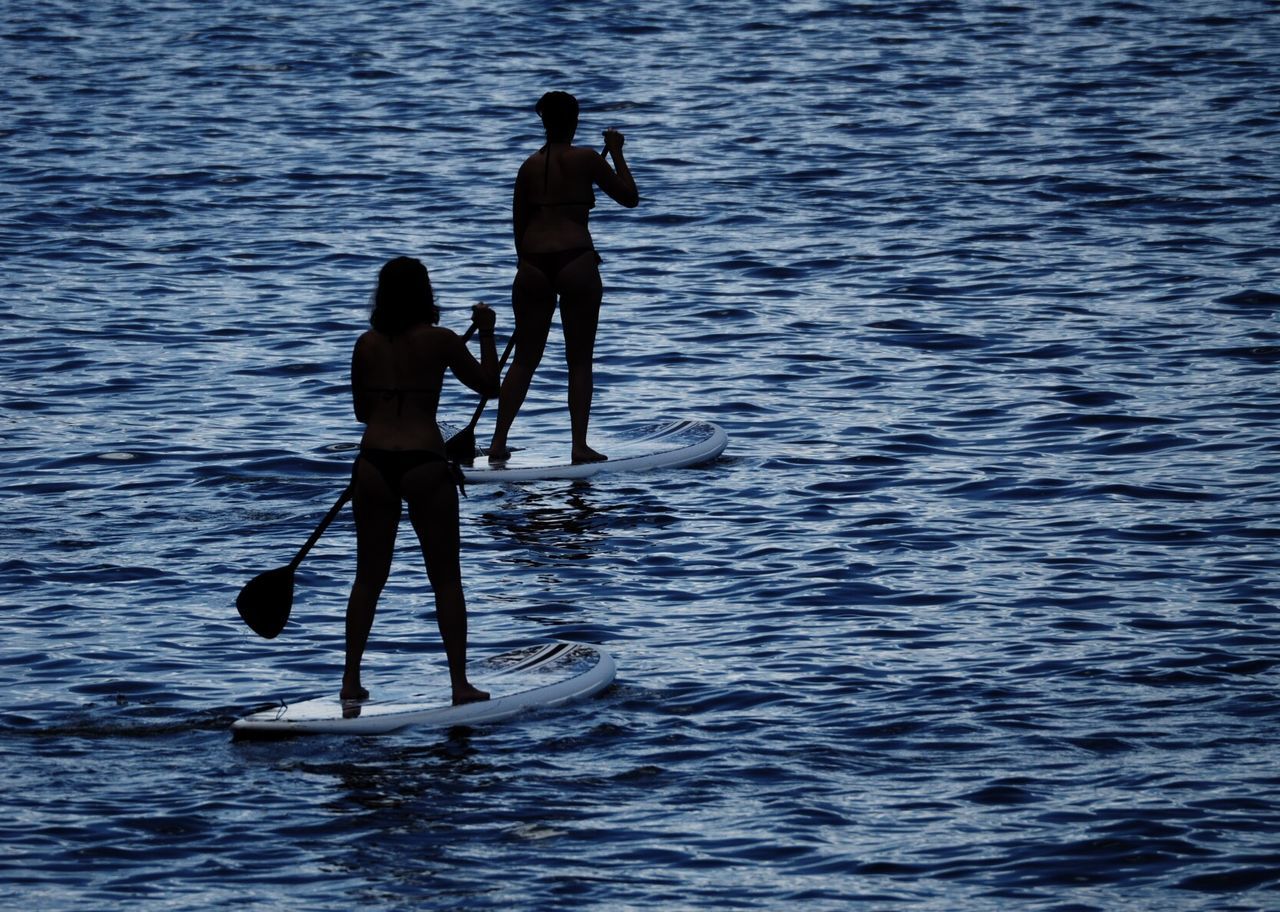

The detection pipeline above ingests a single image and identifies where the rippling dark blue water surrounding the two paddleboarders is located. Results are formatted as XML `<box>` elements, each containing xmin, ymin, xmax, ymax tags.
<box><xmin>0</xmin><ymin>0</ymin><xmax>1280</xmax><ymax>911</ymax></box>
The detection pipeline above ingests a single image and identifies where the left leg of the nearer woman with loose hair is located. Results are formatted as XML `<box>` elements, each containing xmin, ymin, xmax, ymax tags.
<box><xmin>339</xmin><ymin>460</ymin><xmax>401</xmax><ymax>699</ymax></box>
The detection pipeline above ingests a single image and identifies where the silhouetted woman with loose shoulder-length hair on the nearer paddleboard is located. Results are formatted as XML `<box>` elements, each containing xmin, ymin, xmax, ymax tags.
<box><xmin>340</xmin><ymin>256</ymin><xmax>498</xmax><ymax>703</ymax></box>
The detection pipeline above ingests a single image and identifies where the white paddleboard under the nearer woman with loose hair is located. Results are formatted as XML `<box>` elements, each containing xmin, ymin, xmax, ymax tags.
<box><xmin>232</xmin><ymin>643</ymin><xmax>614</xmax><ymax>738</ymax></box>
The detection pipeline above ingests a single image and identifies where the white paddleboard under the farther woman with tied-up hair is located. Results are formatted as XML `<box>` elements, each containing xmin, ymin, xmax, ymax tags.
<box><xmin>450</xmin><ymin>419</ymin><xmax>728</xmax><ymax>484</ymax></box>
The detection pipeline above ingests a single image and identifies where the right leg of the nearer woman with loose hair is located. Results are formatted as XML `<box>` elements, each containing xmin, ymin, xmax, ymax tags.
<box><xmin>404</xmin><ymin>462</ymin><xmax>489</xmax><ymax>704</ymax></box>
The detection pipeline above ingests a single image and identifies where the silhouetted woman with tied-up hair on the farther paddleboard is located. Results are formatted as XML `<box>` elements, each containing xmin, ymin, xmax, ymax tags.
<box><xmin>489</xmin><ymin>92</ymin><xmax>640</xmax><ymax>462</ymax></box>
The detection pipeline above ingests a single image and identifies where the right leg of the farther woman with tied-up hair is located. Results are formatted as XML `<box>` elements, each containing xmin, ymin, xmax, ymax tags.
<box><xmin>558</xmin><ymin>250</ymin><xmax>607</xmax><ymax>462</ymax></box>
